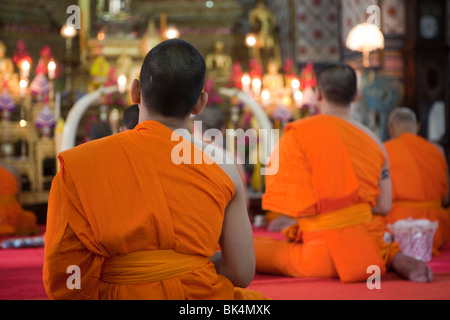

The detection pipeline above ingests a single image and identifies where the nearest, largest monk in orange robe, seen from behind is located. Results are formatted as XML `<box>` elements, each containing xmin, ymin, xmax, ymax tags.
<box><xmin>43</xmin><ymin>39</ymin><xmax>264</xmax><ymax>300</ymax></box>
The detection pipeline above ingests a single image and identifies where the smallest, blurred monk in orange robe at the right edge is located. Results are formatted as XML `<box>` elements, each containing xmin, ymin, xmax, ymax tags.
<box><xmin>385</xmin><ymin>108</ymin><xmax>450</xmax><ymax>255</ymax></box>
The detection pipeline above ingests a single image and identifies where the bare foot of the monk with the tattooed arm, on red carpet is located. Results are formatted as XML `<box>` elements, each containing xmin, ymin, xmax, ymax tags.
<box><xmin>392</xmin><ymin>252</ymin><xmax>433</xmax><ymax>282</ymax></box>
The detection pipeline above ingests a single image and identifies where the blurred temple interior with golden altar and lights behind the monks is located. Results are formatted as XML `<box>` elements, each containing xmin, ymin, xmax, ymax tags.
<box><xmin>0</xmin><ymin>0</ymin><xmax>450</xmax><ymax>223</ymax></box>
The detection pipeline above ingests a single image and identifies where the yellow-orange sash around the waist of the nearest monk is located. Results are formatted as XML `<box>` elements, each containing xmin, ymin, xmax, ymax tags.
<box><xmin>100</xmin><ymin>250</ymin><xmax>209</xmax><ymax>284</ymax></box>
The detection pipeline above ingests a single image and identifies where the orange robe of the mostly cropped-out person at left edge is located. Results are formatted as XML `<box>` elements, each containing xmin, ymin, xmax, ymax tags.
<box><xmin>0</xmin><ymin>167</ymin><xmax>38</xmax><ymax>235</ymax></box>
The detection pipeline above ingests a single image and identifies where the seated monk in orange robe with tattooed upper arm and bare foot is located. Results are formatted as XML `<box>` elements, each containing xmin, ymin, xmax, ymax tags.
<box><xmin>254</xmin><ymin>64</ymin><xmax>433</xmax><ymax>282</ymax></box>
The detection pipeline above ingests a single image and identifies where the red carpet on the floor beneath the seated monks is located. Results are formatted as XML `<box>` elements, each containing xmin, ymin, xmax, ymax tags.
<box><xmin>0</xmin><ymin>229</ymin><xmax>450</xmax><ymax>300</ymax></box>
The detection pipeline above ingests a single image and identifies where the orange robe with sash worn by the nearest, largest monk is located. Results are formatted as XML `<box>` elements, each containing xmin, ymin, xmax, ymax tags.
<box><xmin>43</xmin><ymin>121</ymin><xmax>264</xmax><ymax>300</ymax></box>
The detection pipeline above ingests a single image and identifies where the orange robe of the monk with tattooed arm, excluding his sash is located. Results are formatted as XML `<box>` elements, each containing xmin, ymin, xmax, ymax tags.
<box><xmin>255</xmin><ymin>115</ymin><xmax>399</xmax><ymax>282</ymax></box>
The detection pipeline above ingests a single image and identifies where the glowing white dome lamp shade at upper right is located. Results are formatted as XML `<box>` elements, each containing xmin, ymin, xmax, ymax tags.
<box><xmin>346</xmin><ymin>22</ymin><xmax>384</xmax><ymax>52</ymax></box>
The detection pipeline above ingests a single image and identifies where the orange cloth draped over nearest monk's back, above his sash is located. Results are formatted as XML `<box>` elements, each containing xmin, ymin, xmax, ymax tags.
<box><xmin>62</xmin><ymin>122</ymin><xmax>233</xmax><ymax>255</ymax></box>
